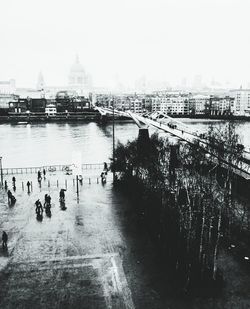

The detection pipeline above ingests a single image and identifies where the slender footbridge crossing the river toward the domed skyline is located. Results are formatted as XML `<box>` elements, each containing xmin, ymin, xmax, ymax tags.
<box><xmin>93</xmin><ymin>107</ymin><xmax>250</xmax><ymax>180</ymax></box>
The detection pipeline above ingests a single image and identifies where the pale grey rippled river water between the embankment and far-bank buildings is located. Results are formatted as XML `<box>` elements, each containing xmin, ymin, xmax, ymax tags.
<box><xmin>0</xmin><ymin>119</ymin><xmax>250</xmax><ymax>167</ymax></box>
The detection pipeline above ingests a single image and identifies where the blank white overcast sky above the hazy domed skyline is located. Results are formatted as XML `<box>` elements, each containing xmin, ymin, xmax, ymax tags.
<box><xmin>0</xmin><ymin>0</ymin><xmax>250</xmax><ymax>87</ymax></box>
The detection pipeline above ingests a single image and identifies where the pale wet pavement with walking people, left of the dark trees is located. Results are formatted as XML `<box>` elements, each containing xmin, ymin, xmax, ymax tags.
<box><xmin>0</xmin><ymin>172</ymin><xmax>137</xmax><ymax>308</ymax></box>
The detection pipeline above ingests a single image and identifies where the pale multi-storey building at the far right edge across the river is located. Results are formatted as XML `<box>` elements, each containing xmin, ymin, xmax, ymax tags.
<box><xmin>230</xmin><ymin>88</ymin><xmax>250</xmax><ymax>116</ymax></box>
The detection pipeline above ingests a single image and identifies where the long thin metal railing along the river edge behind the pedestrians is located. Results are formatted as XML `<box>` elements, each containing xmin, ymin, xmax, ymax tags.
<box><xmin>2</xmin><ymin>163</ymin><xmax>109</xmax><ymax>175</ymax></box>
